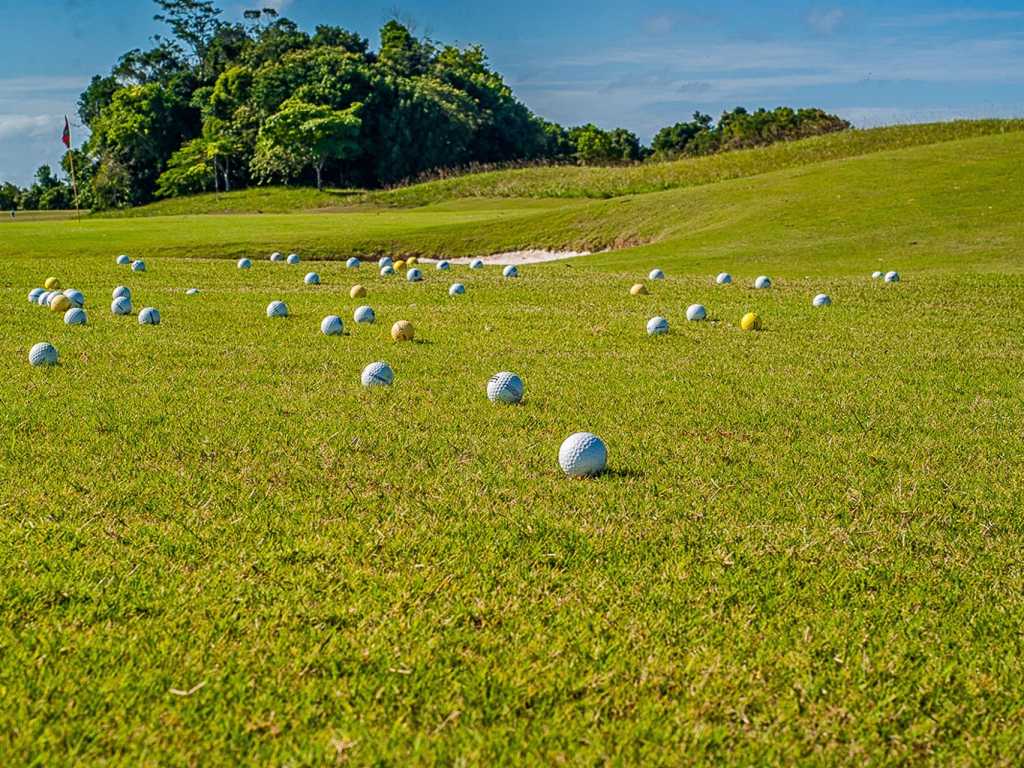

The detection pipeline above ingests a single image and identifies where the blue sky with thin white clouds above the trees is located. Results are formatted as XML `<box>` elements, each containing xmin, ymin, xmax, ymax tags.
<box><xmin>0</xmin><ymin>0</ymin><xmax>1024</xmax><ymax>184</ymax></box>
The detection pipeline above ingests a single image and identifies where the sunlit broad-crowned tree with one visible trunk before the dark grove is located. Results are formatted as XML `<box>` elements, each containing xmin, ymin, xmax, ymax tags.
<box><xmin>262</xmin><ymin>98</ymin><xmax>362</xmax><ymax>189</ymax></box>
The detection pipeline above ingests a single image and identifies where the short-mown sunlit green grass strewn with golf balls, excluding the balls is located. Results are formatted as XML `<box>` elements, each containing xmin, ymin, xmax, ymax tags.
<box><xmin>0</xmin><ymin>128</ymin><xmax>1024</xmax><ymax>765</ymax></box>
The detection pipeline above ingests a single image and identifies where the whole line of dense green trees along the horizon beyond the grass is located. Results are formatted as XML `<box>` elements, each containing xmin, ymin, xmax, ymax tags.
<box><xmin>0</xmin><ymin>0</ymin><xmax>850</xmax><ymax>209</ymax></box>
